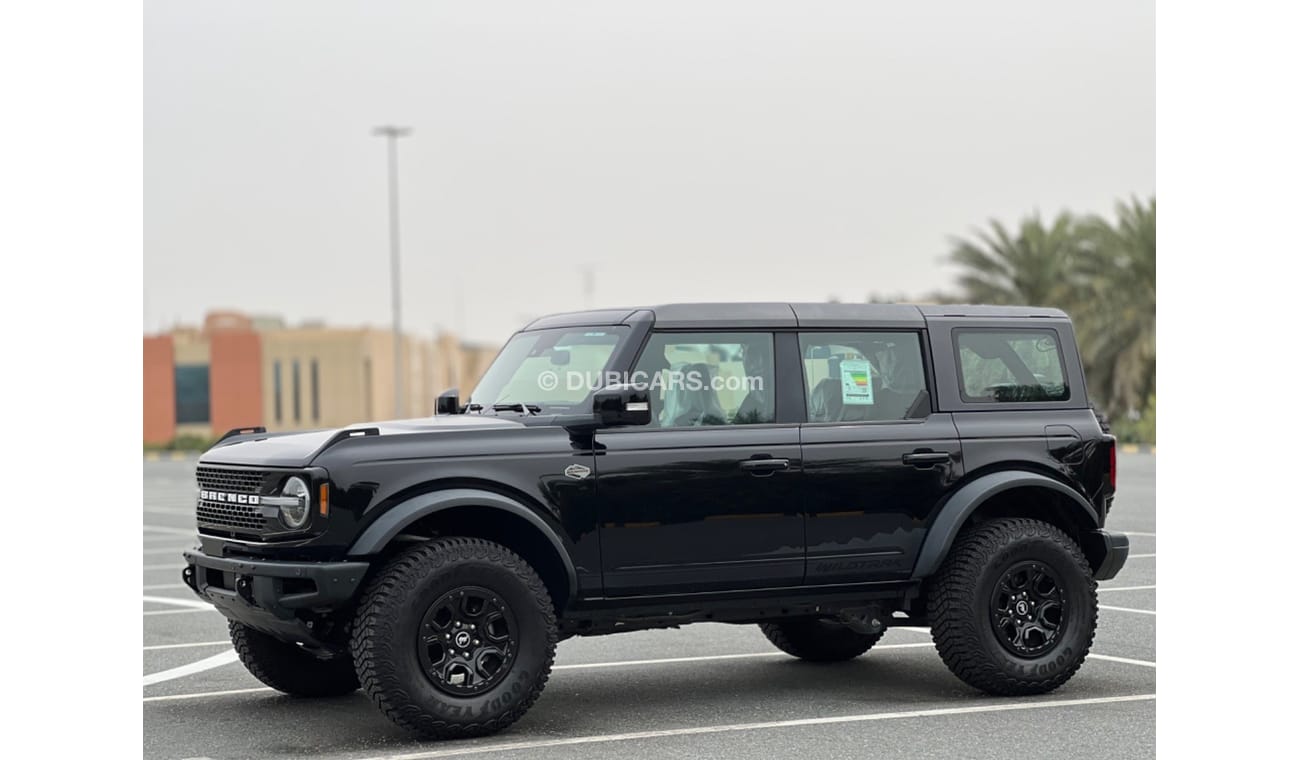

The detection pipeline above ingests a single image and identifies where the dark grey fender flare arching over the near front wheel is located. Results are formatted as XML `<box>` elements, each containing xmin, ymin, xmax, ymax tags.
<box><xmin>347</xmin><ymin>488</ymin><xmax>577</xmax><ymax>594</ymax></box>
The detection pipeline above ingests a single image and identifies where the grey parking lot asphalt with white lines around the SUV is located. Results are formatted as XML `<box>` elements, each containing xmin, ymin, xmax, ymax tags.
<box><xmin>143</xmin><ymin>453</ymin><xmax>1156</xmax><ymax>760</ymax></box>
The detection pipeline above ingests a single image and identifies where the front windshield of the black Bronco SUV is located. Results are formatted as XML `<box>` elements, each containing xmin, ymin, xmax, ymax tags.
<box><xmin>467</xmin><ymin>326</ymin><xmax>628</xmax><ymax>414</ymax></box>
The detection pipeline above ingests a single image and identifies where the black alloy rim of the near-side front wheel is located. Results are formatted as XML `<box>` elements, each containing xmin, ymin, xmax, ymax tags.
<box><xmin>416</xmin><ymin>586</ymin><xmax>519</xmax><ymax>696</ymax></box>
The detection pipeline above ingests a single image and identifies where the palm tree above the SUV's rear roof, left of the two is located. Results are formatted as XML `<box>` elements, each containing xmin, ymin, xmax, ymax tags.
<box><xmin>949</xmin><ymin>212</ymin><xmax>1079</xmax><ymax>308</ymax></box>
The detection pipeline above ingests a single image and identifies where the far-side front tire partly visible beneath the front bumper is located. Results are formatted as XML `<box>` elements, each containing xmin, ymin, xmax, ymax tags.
<box><xmin>230</xmin><ymin>620</ymin><xmax>360</xmax><ymax>696</ymax></box>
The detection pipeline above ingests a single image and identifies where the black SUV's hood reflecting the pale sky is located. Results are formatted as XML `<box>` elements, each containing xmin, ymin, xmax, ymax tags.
<box><xmin>199</xmin><ymin>414</ymin><xmax>524</xmax><ymax>468</ymax></box>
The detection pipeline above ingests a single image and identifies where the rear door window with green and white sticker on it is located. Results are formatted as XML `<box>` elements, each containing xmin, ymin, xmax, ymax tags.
<box><xmin>800</xmin><ymin>333</ymin><xmax>930</xmax><ymax>422</ymax></box>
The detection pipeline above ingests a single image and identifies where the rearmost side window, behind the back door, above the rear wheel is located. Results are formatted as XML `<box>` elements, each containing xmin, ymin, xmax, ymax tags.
<box><xmin>954</xmin><ymin>330</ymin><xmax>1070</xmax><ymax>403</ymax></box>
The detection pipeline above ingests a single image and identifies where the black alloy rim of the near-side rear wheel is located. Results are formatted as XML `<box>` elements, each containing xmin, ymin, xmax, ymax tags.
<box><xmin>989</xmin><ymin>561</ymin><xmax>1069</xmax><ymax>657</ymax></box>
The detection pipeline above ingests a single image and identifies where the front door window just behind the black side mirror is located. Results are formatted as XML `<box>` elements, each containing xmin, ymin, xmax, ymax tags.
<box><xmin>633</xmin><ymin>333</ymin><xmax>776</xmax><ymax>427</ymax></box>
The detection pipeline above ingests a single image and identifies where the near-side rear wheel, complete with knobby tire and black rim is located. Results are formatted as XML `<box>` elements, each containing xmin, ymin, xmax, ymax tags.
<box><xmin>927</xmin><ymin>518</ymin><xmax>1097</xmax><ymax>695</ymax></box>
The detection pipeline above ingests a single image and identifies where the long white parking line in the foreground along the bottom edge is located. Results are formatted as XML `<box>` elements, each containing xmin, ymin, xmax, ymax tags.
<box><xmin>351</xmin><ymin>694</ymin><xmax>1156</xmax><ymax>760</ymax></box>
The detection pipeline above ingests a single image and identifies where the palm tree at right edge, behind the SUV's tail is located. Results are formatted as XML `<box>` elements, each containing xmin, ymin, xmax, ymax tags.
<box><xmin>1075</xmin><ymin>197</ymin><xmax>1156</xmax><ymax>414</ymax></box>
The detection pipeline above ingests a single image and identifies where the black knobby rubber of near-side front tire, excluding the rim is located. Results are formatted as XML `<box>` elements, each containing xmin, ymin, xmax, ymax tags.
<box><xmin>351</xmin><ymin>538</ymin><xmax>556</xmax><ymax>738</ymax></box>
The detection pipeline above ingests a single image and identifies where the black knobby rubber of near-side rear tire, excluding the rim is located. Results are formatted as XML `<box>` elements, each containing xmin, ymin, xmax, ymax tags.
<box><xmin>927</xmin><ymin>518</ymin><xmax>1097</xmax><ymax>695</ymax></box>
